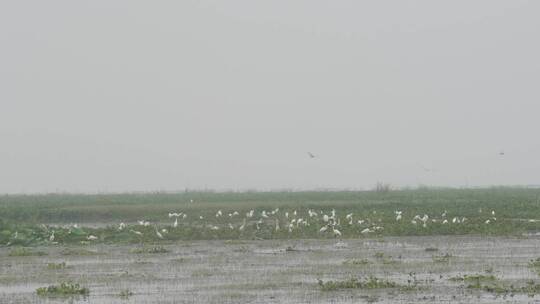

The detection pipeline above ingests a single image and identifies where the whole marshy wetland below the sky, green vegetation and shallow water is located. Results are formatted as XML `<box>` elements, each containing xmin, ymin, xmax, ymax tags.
<box><xmin>0</xmin><ymin>188</ymin><xmax>540</xmax><ymax>303</ymax></box>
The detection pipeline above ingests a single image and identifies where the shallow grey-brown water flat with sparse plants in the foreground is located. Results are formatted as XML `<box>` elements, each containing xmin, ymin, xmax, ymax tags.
<box><xmin>0</xmin><ymin>236</ymin><xmax>540</xmax><ymax>303</ymax></box>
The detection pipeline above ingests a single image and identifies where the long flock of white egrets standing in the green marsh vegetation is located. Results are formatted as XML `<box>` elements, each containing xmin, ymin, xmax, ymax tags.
<box><xmin>3</xmin><ymin>208</ymin><xmax>497</xmax><ymax>244</ymax></box>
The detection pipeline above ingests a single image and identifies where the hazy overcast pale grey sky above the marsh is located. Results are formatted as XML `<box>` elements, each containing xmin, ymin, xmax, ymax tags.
<box><xmin>0</xmin><ymin>0</ymin><xmax>540</xmax><ymax>193</ymax></box>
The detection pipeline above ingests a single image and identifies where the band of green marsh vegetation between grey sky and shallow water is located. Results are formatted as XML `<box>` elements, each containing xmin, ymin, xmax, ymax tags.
<box><xmin>0</xmin><ymin>188</ymin><xmax>540</xmax><ymax>245</ymax></box>
